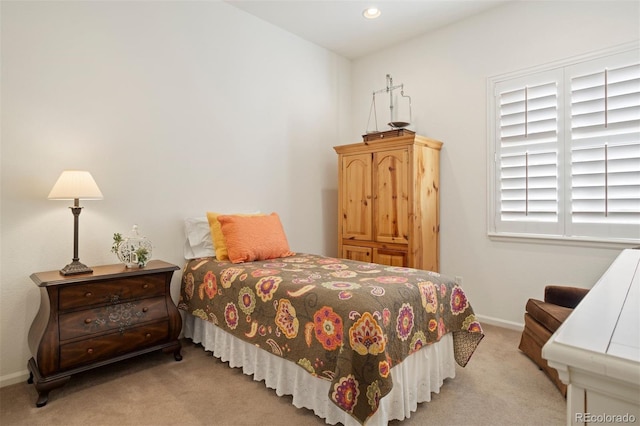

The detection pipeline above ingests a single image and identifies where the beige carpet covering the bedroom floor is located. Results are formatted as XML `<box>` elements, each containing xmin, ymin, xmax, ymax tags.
<box><xmin>0</xmin><ymin>325</ymin><xmax>566</xmax><ymax>426</ymax></box>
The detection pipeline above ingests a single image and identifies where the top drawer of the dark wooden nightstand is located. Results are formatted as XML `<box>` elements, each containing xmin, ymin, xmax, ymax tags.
<box><xmin>59</xmin><ymin>274</ymin><xmax>165</xmax><ymax>310</ymax></box>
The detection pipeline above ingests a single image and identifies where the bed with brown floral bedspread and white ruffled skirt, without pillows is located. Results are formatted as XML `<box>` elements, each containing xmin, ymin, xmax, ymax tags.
<box><xmin>178</xmin><ymin>216</ymin><xmax>483</xmax><ymax>425</ymax></box>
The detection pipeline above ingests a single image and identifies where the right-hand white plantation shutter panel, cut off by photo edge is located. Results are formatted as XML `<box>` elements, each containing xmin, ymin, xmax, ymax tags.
<box><xmin>567</xmin><ymin>54</ymin><xmax>640</xmax><ymax>238</ymax></box>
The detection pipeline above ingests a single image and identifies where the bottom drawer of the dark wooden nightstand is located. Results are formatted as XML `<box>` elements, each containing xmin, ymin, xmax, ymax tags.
<box><xmin>60</xmin><ymin>321</ymin><xmax>169</xmax><ymax>370</ymax></box>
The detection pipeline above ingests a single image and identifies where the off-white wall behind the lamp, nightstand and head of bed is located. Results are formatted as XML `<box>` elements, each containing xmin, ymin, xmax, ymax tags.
<box><xmin>0</xmin><ymin>1</ymin><xmax>350</xmax><ymax>385</ymax></box>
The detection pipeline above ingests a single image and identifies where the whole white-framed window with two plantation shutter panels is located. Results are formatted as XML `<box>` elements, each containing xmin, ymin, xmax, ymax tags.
<box><xmin>488</xmin><ymin>45</ymin><xmax>640</xmax><ymax>243</ymax></box>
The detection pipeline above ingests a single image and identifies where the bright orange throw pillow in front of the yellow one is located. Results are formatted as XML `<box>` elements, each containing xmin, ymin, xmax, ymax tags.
<box><xmin>217</xmin><ymin>213</ymin><xmax>295</xmax><ymax>263</ymax></box>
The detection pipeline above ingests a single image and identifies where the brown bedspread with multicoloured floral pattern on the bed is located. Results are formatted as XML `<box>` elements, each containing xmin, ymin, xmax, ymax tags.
<box><xmin>178</xmin><ymin>254</ymin><xmax>484</xmax><ymax>424</ymax></box>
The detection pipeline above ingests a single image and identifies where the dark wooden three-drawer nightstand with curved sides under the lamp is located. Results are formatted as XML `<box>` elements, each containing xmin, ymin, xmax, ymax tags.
<box><xmin>27</xmin><ymin>260</ymin><xmax>182</xmax><ymax>407</ymax></box>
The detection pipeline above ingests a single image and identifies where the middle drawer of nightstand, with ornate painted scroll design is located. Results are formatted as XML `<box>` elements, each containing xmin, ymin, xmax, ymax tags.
<box><xmin>60</xmin><ymin>296</ymin><xmax>167</xmax><ymax>340</ymax></box>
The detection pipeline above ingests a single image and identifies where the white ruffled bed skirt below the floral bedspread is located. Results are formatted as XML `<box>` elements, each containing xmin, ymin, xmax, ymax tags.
<box><xmin>183</xmin><ymin>314</ymin><xmax>456</xmax><ymax>426</ymax></box>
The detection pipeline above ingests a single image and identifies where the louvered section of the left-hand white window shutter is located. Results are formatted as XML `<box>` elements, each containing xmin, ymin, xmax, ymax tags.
<box><xmin>499</xmin><ymin>81</ymin><xmax>558</xmax><ymax>222</ymax></box>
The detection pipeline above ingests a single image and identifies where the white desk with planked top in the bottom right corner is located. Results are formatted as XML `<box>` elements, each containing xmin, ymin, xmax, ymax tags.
<box><xmin>542</xmin><ymin>249</ymin><xmax>640</xmax><ymax>425</ymax></box>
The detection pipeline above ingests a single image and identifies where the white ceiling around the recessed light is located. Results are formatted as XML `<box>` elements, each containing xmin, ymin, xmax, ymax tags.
<box><xmin>227</xmin><ymin>0</ymin><xmax>513</xmax><ymax>59</ymax></box>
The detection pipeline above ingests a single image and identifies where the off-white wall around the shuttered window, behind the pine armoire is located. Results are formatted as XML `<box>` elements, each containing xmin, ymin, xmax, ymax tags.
<box><xmin>352</xmin><ymin>1</ymin><xmax>640</xmax><ymax>327</ymax></box>
